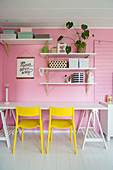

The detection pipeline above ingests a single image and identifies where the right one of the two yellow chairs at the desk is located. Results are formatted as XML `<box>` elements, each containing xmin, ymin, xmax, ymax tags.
<box><xmin>47</xmin><ymin>107</ymin><xmax>77</xmax><ymax>154</ymax></box>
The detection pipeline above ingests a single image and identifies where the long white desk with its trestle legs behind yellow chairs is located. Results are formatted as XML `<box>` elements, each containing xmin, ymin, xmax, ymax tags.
<box><xmin>0</xmin><ymin>102</ymin><xmax>108</xmax><ymax>149</ymax></box>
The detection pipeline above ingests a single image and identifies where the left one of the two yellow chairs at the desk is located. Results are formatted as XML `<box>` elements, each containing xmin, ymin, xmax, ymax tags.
<box><xmin>13</xmin><ymin>107</ymin><xmax>43</xmax><ymax>154</ymax></box>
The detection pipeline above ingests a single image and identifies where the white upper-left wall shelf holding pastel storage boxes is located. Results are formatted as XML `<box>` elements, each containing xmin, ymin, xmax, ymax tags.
<box><xmin>0</xmin><ymin>38</ymin><xmax>53</xmax><ymax>45</ymax></box>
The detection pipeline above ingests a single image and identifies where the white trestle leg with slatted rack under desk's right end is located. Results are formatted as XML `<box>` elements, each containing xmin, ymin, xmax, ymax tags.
<box><xmin>77</xmin><ymin>110</ymin><xmax>107</xmax><ymax>149</ymax></box>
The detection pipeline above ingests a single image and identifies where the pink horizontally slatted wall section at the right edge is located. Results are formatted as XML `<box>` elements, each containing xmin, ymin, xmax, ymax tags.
<box><xmin>95</xmin><ymin>42</ymin><xmax>113</xmax><ymax>101</ymax></box>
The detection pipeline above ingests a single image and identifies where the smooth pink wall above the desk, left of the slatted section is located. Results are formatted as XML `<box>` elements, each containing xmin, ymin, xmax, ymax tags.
<box><xmin>3</xmin><ymin>29</ymin><xmax>94</xmax><ymax>102</ymax></box>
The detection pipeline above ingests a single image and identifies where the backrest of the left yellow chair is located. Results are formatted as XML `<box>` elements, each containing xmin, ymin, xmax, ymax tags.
<box><xmin>16</xmin><ymin>106</ymin><xmax>41</xmax><ymax>117</ymax></box>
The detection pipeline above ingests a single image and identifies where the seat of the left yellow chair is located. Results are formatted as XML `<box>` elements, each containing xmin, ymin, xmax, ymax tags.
<box><xmin>18</xmin><ymin>119</ymin><xmax>40</xmax><ymax>129</ymax></box>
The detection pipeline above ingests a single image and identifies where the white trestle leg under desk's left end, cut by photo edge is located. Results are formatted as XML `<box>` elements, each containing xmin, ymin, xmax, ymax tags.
<box><xmin>0</xmin><ymin>110</ymin><xmax>15</xmax><ymax>148</ymax></box>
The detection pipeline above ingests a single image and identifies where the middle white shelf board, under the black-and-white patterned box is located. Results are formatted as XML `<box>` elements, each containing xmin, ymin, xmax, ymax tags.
<box><xmin>43</xmin><ymin>67</ymin><xmax>96</xmax><ymax>71</ymax></box>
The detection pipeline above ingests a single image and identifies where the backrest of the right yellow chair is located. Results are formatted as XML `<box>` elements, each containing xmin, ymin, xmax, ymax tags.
<box><xmin>49</xmin><ymin>107</ymin><xmax>74</xmax><ymax>117</ymax></box>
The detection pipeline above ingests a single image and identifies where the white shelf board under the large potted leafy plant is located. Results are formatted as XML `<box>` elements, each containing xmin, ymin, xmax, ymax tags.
<box><xmin>40</xmin><ymin>53</ymin><xmax>96</xmax><ymax>57</ymax></box>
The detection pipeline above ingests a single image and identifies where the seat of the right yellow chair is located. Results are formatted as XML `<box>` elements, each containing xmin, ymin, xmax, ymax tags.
<box><xmin>51</xmin><ymin>119</ymin><xmax>73</xmax><ymax>129</ymax></box>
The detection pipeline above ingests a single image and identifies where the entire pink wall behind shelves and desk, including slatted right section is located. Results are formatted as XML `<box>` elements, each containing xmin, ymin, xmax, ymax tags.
<box><xmin>2</xmin><ymin>29</ymin><xmax>113</xmax><ymax>130</ymax></box>
